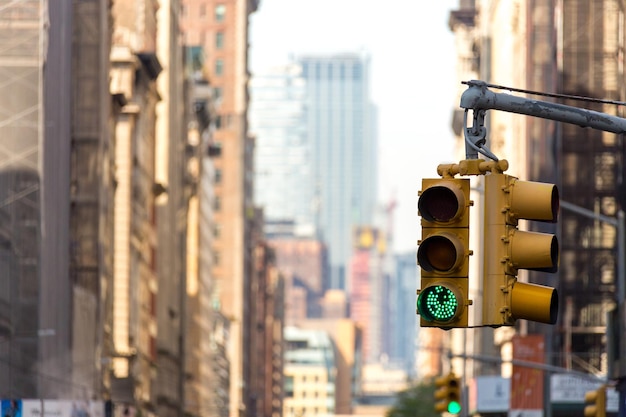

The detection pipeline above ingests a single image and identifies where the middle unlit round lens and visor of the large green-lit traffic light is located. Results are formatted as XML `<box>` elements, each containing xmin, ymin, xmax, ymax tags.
<box><xmin>417</xmin><ymin>232</ymin><xmax>466</xmax><ymax>273</ymax></box>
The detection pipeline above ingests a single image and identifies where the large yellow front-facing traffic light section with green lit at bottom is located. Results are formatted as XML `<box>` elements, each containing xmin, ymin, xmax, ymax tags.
<box><xmin>417</xmin><ymin>178</ymin><xmax>472</xmax><ymax>329</ymax></box>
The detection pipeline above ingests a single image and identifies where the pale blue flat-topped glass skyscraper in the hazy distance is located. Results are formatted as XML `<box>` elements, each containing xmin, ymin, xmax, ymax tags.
<box><xmin>298</xmin><ymin>53</ymin><xmax>377</xmax><ymax>289</ymax></box>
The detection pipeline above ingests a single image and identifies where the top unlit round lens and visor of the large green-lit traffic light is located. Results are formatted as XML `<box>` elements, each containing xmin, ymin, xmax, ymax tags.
<box><xmin>417</xmin><ymin>183</ymin><xmax>466</xmax><ymax>223</ymax></box>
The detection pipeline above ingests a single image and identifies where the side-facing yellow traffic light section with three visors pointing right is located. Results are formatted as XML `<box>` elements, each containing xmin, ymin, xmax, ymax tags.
<box><xmin>482</xmin><ymin>172</ymin><xmax>559</xmax><ymax>327</ymax></box>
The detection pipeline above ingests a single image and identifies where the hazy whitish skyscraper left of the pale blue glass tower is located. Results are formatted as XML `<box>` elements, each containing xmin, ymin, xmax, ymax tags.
<box><xmin>250</xmin><ymin>64</ymin><xmax>315</xmax><ymax>237</ymax></box>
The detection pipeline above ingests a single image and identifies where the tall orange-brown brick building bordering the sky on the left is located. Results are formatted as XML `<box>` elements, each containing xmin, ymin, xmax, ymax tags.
<box><xmin>181</xmin><ymin>0</ymin><xmax>260</xmax><ymax>416</ymax></box>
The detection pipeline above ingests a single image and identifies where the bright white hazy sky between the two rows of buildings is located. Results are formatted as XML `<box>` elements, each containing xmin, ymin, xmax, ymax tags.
<box><xmin>250</xmin><ymin>0</ymin><xmax>458</xmax><ymax>252</ymax></box>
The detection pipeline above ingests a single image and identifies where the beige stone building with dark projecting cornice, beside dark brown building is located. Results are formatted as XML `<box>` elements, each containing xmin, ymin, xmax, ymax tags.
<box><xmin>110</xmin><ymin>1</ymin><xmax>162</xmax><ymax>411</ymax></box>
